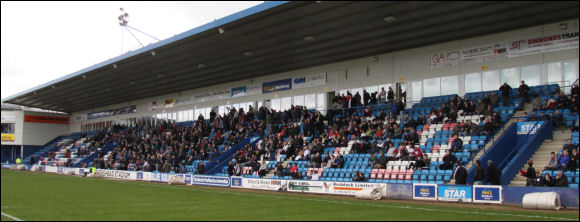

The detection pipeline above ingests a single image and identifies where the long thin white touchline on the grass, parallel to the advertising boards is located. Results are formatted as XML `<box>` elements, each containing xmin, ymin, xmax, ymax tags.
<box><xmin>107</xmin><ymin>180</ymin><xmax>578</xmax><ymax>221</ymax></box>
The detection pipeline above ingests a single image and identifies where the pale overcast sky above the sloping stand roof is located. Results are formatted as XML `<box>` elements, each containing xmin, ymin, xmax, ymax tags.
<box><xmin>1</xmin><ymin>1</ymin><xmax>263</xmax><ymax>99</ymax></box>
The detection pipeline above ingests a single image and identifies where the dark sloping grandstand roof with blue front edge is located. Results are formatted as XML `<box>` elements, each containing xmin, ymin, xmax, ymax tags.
<box><xmin>3</xmin><ymin>1</ymin><xmax>579</xmax><ymax>113</ymax></box>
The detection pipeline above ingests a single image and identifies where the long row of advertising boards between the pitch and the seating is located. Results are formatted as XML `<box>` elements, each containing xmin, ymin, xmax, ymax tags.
<box><xmin>2</xmin><ymin>164</ymin><xmax>578</xmax><ymax>208</ymax></box>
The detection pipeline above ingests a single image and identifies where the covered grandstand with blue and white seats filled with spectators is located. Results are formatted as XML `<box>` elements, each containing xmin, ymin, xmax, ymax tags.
<box><xmin>2</xmin><ymin>1</ymin><xmax>580</xmax><ymax>219</ymax></box>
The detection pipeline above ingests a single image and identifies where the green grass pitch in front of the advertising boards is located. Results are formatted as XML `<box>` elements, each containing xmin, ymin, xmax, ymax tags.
<box><xmin>2</xmin><ymin>169</ymin><xmax>578</xmax><ymax>221</ymax></box>
